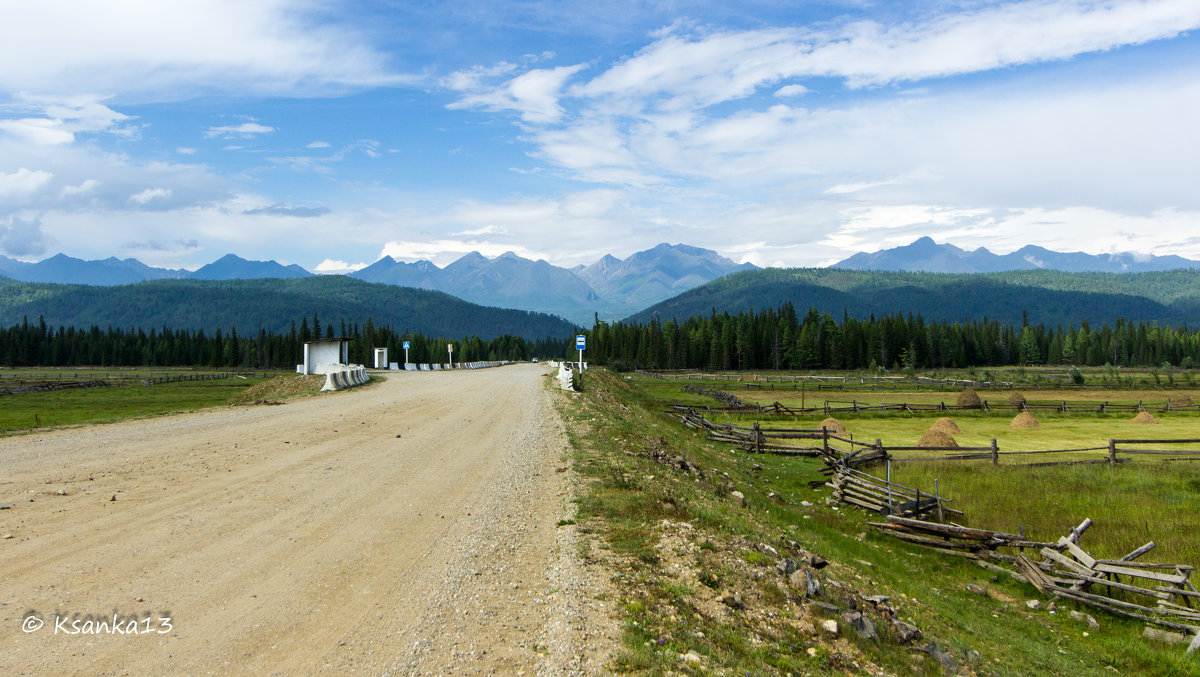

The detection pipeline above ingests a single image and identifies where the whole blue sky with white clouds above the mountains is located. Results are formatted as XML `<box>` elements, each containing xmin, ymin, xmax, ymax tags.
<box><xmin>0</xmin><ymin>0</ymin><xmax>1200</xmax><ymax>272</ymax></box>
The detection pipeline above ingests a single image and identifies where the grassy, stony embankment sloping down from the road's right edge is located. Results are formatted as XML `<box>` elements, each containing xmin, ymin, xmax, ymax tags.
<box><xmin>564</xmin><ymin>370</ymin><xmax>1200</xmax><ymax>676</ymax></box>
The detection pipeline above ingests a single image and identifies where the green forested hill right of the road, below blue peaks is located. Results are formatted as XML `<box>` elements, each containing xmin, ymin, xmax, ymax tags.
<box><xmin>629</xmin><ymin>268</ymin><xmax>1200</xmax><ymax>326</ymax></box>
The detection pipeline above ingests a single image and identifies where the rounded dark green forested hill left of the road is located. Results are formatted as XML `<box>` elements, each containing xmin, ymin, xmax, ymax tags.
<box><xmin>0</xmin><ymin>276</ymin><xmax>574</xmax><ymax>340</ymax></box>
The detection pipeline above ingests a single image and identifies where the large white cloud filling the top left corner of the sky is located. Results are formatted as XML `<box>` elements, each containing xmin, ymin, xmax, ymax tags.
<box><xmin>0</xmin><ymin>0</ymin><xmax>415</xmax><ymax>100</ymax></box>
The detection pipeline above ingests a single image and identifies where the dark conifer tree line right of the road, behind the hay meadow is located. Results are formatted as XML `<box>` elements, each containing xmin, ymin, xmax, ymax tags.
<box><xmin>588</xmin><ymin>302</ymin><xmax>1200</xmax><ymax>371</ymax></box>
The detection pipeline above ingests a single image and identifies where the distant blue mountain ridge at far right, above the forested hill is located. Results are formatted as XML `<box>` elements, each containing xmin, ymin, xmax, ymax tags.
<box><xmin>830</xmin><ymin>238</ymin><xmax>1200</xmax><ymax>272</ymax></box>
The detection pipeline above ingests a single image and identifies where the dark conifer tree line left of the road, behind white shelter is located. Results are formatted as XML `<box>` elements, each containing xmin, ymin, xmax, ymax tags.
<box><xmin>0</xmin><ymin>313</ymin><xmax>570</xmax><ymax>369</ymax></box>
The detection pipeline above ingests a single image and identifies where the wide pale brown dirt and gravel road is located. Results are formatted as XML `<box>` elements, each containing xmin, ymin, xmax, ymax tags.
<box><xmin>0</xmin><ymin>365</ymin><xmax>614</xmax><ymax>675</ymax></box>
